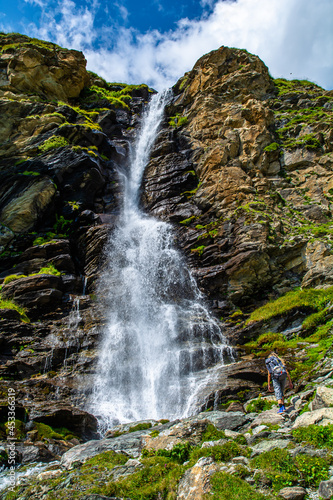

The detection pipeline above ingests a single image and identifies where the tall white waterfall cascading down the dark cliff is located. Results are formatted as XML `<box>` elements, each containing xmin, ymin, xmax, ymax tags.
<box><xmin>90</xmin><ymin>93</ymin><xmax>232</xmax><ymax>432</ymax></box>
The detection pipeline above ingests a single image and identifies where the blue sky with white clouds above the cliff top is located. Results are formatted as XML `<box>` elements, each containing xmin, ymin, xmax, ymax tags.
<box><xmin>0</xmin><ymin>0</ymin><xmax>333</xmax><ymax>90</ymax></box>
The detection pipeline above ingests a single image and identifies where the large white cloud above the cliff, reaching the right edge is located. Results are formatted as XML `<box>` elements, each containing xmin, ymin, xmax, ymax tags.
<box><xmin>24</xmin><ymin>0</ymin><xmax>333</xmax><ymax>89</ymax></box>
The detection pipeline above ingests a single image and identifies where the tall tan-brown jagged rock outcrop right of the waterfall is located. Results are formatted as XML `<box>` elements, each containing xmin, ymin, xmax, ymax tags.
<box><xmin>143</xmin><ymin>47</ymin><xmax>332</xmax><ymax>313</ymax></box>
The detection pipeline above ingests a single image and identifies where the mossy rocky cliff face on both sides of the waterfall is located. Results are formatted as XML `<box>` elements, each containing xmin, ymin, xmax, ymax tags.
<box><xmin>0</xmin><ymin>34</ymin><xmax>333</xmax><ymax>480</ymax></box>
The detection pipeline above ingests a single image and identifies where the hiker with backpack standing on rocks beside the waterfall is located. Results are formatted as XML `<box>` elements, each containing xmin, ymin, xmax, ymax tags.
<box><xmin>265</xmin><ymin>352</ymin><xmax>293</xmax><ymax>413</ymax></box>
